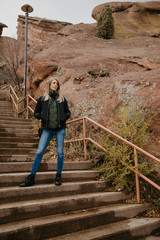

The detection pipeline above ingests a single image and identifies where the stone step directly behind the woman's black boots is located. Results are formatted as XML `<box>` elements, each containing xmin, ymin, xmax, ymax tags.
<box><xmin>0</xmin><ymin>170</ymin><xmax>98</xmax><ymax>187</ymax></box>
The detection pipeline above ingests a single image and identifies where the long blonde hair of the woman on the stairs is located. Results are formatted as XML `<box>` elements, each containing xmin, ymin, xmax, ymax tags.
<box><xmin>44</xmin><ymin>77</ymin><xmax>64</xmax><ymax>102</ymax></box>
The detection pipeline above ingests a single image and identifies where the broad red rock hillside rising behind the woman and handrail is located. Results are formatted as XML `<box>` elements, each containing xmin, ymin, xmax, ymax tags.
<box><xmin>1</xmin><ymin>2</ymin><xmax>160</xmax><ymax>157</ymax></box>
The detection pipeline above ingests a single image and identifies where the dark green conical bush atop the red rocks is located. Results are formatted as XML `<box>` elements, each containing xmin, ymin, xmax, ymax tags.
<box><xmin>97</xmin><ymin>5</ymin><xmax>114</xmax><ymax>39</ymax></box>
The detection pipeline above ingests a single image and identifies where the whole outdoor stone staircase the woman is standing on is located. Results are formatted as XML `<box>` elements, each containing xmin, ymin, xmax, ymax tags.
<box><xmin>0</xmin><ymin>92</ymin><xmax>160</xmax><ymax>240</ymax></box>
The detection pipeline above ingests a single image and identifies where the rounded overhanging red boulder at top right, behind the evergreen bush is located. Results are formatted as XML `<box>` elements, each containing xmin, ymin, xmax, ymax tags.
<box><xmin>92</xmin><ymin>1</ymin><xmax>160</xmax><ymax>37</ymax></box>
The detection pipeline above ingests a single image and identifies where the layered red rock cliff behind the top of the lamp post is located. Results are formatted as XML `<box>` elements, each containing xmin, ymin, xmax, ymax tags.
<box><xmin>17</xmin><ymin>15</ymin><xmax>71</xmax><ymax>45</ymax></box>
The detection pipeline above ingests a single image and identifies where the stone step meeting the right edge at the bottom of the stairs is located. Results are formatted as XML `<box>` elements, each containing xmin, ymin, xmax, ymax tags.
<box><xmin>52</xmin><ymin>218</ymin><xmax>160</xmax><ymax>240</ymax></box>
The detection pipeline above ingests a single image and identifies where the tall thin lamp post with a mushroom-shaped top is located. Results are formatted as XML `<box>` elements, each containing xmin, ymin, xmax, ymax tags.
<box><xmin>21</xmin><ymin>4</ymin><xmax>33</xmax><ymax>109</ymax></box>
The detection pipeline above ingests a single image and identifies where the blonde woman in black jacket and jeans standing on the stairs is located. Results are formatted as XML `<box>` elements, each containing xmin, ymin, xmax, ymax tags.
<box><xmin>20</xmin><ymin>77</ymin><xmax>70</xmax><ymax>187</ymax></box>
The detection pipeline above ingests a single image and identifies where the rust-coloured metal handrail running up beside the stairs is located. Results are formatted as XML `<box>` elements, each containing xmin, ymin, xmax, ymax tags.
<box><xmin>9</xmin><ymin>86</ymin><xmax>160</xmax><ymax>203</ymax></box>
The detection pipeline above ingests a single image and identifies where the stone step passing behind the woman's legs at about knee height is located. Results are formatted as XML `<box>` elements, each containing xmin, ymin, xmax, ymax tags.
<box><xmin>0</xmin><ymin>154</ymin><xmax>51</xmax><ymax>162</ymax></box>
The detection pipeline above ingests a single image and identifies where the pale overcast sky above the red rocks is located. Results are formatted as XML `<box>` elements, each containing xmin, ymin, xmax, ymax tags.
<box><xmin>0</xmin><ymin>0</ymin><xmax>160</xmax><ymax>38</ymax></box>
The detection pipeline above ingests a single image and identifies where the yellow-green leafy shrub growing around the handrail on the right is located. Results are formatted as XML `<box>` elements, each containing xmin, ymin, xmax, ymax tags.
<box><xmin>99</xmin><ymin>103</ymin><xmax>156</xmax><ymax>191</ymax></box>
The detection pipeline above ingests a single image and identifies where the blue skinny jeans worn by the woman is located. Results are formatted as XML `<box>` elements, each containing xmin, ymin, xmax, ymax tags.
<box><xmin>31</xmin><ymin>129</ymin><xmax>65</xmax><ymax>174</ymax></box>
